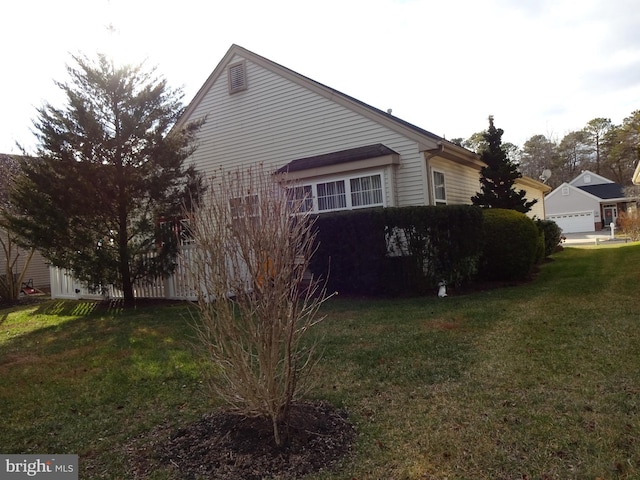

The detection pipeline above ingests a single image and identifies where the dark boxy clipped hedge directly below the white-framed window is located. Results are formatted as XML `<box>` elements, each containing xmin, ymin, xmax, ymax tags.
<box><xmin>311</xmin><ymin>205</ymin><xmax>482</xmax><ymax>295</ymax></box>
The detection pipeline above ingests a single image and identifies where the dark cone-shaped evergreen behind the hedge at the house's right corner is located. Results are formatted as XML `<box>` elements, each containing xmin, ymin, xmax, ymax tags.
<box><xmin>471</xmin><ymin>116</ymin><xmax>537</xmax><ymax>213</ymax></box>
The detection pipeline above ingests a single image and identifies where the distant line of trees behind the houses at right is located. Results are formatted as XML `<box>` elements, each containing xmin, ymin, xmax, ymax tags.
<box><xmin>452</xmin><ymin>110</ymin><xmax>640</xmax><ymax>188</ymax></box>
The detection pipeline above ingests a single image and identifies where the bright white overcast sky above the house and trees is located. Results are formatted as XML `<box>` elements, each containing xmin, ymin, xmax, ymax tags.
<box><xmin>0</xmin><ymin>0</ymin><xmax>640</xmax><ymax>153</ymax></box>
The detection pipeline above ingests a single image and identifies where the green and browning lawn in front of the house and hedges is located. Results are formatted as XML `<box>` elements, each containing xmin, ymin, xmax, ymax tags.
<box><xmin>0</xmin><ymin>244</ymin><xmax>640</xmax><ymax>480</ymax></box>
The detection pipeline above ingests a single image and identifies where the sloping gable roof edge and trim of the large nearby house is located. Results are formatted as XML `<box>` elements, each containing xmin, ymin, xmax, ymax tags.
<box><xmin>174</xmin><ymin>44</ymin><xmax>485</xmax><ymax>168</ymax></box>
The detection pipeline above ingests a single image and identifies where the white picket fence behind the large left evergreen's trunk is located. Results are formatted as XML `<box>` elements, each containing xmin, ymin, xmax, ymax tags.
<box><xmin>49</xmin><ymin>245</ymin><xmax>196</xmax><ymax>300</ymax></box>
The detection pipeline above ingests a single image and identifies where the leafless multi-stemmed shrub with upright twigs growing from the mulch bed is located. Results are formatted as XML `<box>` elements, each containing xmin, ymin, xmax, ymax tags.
<box><xmin>186</xmin><ymin>165</ymin><xmax>328</xmax><ymax>446</ymax></box>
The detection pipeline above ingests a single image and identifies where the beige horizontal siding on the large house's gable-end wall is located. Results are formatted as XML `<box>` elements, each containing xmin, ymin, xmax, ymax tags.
<box><xmin>190</xmin><ymin>56</ymin><xmax>435</xmax><ymax>206</ymax></box>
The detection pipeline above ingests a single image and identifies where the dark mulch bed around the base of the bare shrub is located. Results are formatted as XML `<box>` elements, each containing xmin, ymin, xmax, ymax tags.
<box><xmin>129</xmin><ymin>402</ymin><xmax>355</xmax><ymax>480</ymax></box>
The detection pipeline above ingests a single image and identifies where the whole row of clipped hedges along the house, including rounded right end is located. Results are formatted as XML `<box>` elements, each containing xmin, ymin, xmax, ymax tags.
<box><xmin>311</xmin><ymin>205</ymin><xmax>544</xmax><ymax>296</ymax></box>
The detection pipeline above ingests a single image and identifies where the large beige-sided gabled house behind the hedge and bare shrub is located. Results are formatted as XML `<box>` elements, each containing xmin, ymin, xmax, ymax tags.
<box><xmin>178</xmin><ymin>45</ymin><xmax>548</xmax><ymax>218</ymax></box>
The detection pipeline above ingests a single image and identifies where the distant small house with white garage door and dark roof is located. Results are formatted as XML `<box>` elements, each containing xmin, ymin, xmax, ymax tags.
<box><xmin>544</xmin><ymin>170</ymin><xmax>635</xmax><ymax>233</ymax></box>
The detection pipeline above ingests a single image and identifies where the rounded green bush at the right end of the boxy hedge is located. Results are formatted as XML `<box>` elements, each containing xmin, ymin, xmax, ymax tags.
<box><xmin>480</xmin><ymin>208</ymin><xmax>539</xmax><ymax>280</ymax></box>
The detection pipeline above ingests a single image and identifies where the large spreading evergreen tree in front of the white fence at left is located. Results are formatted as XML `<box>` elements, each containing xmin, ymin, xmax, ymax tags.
<box><xmin>8</xmin><ymin>55</ymin><xmax>202</xmax><ymax>304</ymax></box>
